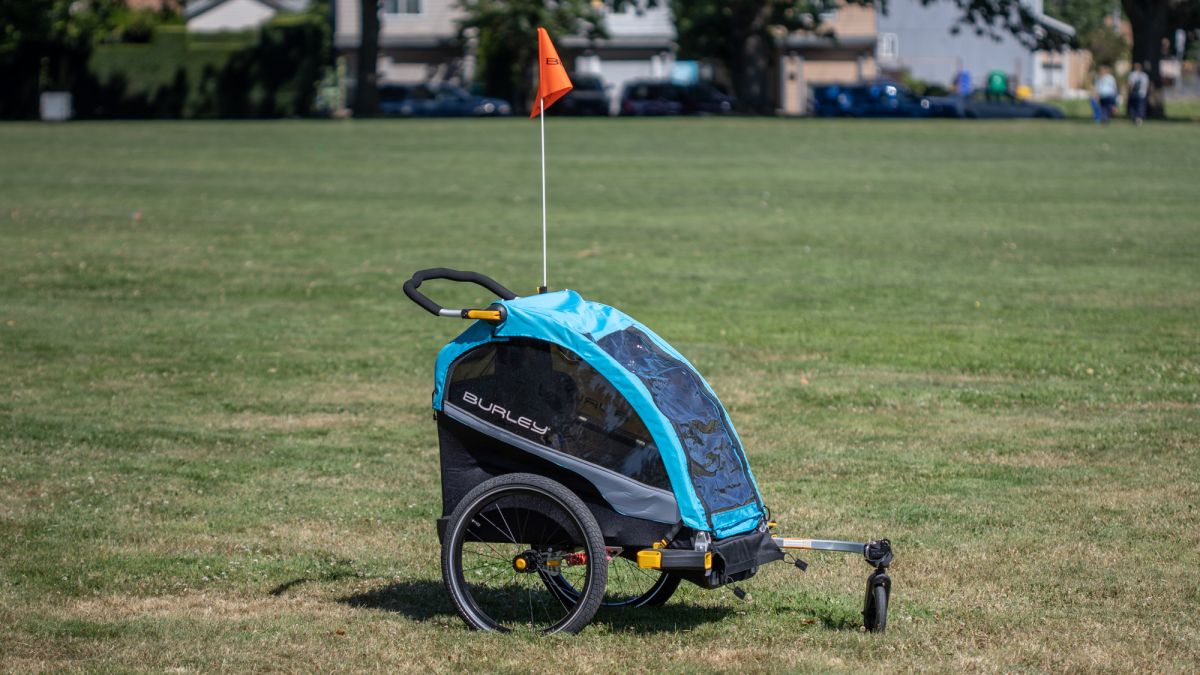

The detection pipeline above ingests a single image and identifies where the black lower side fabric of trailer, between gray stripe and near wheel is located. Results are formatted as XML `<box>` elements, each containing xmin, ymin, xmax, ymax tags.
<box><xmin>438</xmin><ymin>414</ymin><xmax>691</xmax><ymax>547</ymax></box>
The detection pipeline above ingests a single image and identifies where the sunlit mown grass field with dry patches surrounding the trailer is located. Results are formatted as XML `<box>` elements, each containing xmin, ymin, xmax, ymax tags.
<box><xmin>7</xmin><ymin>119</ymin><xmax>1200</xmax><ymax>671</ymax></box>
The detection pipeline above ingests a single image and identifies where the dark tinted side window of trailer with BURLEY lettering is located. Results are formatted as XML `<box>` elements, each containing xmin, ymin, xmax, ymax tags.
<box><xmin>445</xmin><ymin>340</ymin><xmax>671</xmax><ymax>490</ymax></box>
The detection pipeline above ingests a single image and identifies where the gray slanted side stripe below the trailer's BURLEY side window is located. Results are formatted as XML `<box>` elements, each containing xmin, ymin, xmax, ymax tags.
<box><xmin>442</xmin><ymin>402</ymin><xmax>679</xmax><ymax>525</ymax></box>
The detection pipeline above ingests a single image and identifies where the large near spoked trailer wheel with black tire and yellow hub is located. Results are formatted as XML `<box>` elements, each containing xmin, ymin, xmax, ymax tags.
<box><xmin>442</xmin><ymin>473</ymin><xmax>608</xmax><ymax>633</ymax></box>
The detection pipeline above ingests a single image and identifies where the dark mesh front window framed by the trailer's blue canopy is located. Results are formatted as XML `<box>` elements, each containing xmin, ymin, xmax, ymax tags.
<box><xmin>596</xmin><ymin>328</ymin><xmax>757</xmax><ymax>513</ymax></box>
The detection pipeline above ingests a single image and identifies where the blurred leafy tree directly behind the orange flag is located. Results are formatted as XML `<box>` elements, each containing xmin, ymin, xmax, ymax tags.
<box><xmin>458</xmin><ymin>0</ymin><xmax>605</xmax><ymax>110</ymax></box>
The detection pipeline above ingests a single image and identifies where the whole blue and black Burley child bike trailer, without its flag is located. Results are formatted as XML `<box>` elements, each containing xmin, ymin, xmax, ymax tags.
<box><xmin>404</xmin><ymin>268</ymin><xmax>892</xmax><ymax>633</ymax></box>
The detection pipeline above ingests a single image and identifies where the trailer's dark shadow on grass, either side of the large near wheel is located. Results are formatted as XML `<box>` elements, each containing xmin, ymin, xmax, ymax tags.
<box><xmin>337</xmin><ymin>580</ymin><xmax>734</xmax><ymax>633</ymax></box>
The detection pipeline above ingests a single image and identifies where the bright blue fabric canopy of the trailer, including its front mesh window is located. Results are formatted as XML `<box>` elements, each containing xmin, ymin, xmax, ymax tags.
<box><xmin>433</xmin><ymin>291</ymin><xmax>764</xmax><ymax>538</ymax></box>
